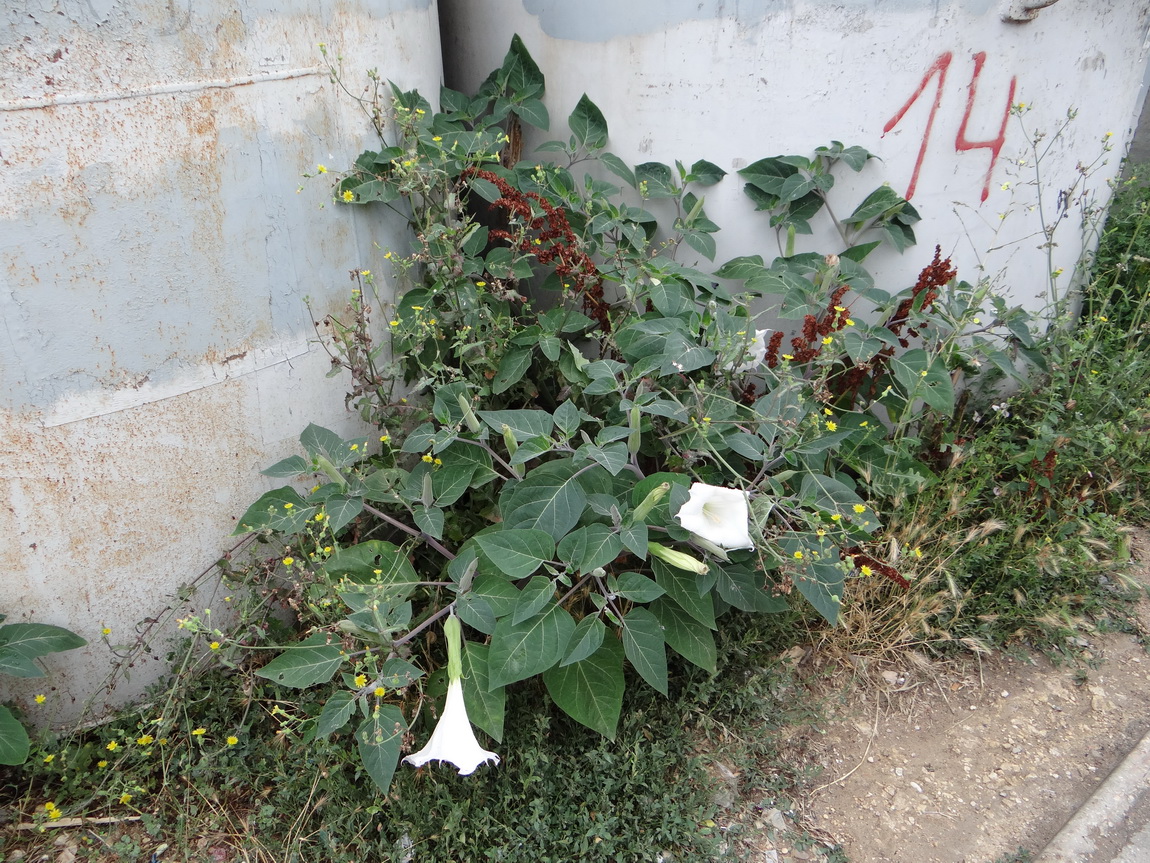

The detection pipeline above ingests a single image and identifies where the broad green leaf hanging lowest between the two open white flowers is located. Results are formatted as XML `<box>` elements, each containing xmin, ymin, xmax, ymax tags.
<box><xmin>543</xmin><ymin>639</ymin><xmax>623</xmax><ymax>740</ymax></box>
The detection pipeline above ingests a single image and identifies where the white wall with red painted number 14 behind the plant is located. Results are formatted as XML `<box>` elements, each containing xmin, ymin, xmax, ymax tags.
<box><xmin>440</xmin><ymin>0</ymin><xmax>1150</xmax><ymax>308</ymax></box>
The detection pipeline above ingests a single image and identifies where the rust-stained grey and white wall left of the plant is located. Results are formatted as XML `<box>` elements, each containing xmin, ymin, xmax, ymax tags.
<box><xmin>0</xmin><ymin>0</ymin><xmax>442</xmax><ymax>719</ymax></box>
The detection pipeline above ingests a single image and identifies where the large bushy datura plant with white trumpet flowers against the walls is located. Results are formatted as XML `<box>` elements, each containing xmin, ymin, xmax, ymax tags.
<box><xmin>226</xmin><ymin>38</ymin><xmax>1044</xmax><ymax>789</ymax></box>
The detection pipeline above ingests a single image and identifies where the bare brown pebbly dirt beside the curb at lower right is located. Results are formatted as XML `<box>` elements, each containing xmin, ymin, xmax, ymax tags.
<box><xmin>736</xmin><ymin>530</ymin><xmax>1150</xmax><ymax>863</ymax></box>
